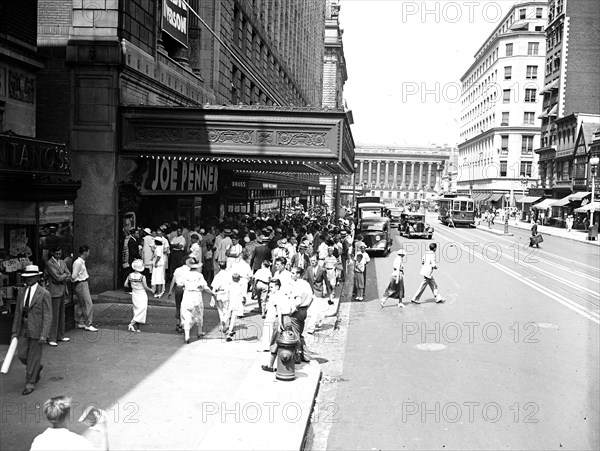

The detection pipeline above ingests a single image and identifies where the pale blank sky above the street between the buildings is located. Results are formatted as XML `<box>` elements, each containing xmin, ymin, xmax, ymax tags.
<box><xmin>339</xmin><ymin>0</ymin><xmax>515</xmax><ymax>146</ymax></box>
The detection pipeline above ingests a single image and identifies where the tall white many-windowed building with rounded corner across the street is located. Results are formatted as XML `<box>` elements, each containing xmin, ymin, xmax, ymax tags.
<box><xmin>457</xmin><ymin>0</ymin><xmax>547</xmax><ymax>207</ymax></box>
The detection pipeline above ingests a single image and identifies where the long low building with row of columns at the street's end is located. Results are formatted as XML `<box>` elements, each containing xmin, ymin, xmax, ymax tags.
<box><xmin>341</xmin><ymin>146</ymin><xmax>456</xmax><ymax>206</ymax></box>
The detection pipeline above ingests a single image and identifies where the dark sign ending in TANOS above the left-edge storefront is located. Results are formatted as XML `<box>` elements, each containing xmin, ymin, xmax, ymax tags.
<box><xmin>0</xmin><ymin>134</ymin><xmax>71</xmax><ymax>175</ymax></box>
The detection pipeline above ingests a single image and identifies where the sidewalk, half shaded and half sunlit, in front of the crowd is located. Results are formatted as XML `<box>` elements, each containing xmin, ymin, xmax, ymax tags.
<box><xmin>0</xmin><ymin>281</ymin><xmax>351</xmax><ymax>450</ymax></box>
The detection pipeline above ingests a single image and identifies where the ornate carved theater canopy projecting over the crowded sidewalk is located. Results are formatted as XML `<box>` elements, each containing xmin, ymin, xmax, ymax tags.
<box><xmin>120</xmin><ymin>105</ymin><xmax>354</xmax><ymax>175</ymax></box>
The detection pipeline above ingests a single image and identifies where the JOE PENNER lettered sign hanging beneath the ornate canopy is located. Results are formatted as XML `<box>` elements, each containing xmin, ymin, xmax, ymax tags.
<box><xmin>143</xmin><ymin>159</ymin><xmax>219</xmax><ymax>194</ymax></box>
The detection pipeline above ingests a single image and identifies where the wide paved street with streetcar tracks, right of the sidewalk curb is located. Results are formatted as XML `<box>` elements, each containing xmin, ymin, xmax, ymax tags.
<box><xmin>324</xmin><ymin>219</ymin><xmax>600</xmax><ymax>449</ymax></box>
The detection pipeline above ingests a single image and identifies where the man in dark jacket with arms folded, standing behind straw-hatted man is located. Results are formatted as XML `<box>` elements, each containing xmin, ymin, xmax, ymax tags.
<box><xmin>45</xmin><ymin>246</ymin><xmax>71</xmax><ymax>346</ymax></box>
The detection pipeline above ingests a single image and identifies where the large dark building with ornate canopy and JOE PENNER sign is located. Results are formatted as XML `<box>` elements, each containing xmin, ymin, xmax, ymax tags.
<box><xmin>30</xmin><ymin>0</ymin><xmax>354</xmax><ymax>291</ymax></box>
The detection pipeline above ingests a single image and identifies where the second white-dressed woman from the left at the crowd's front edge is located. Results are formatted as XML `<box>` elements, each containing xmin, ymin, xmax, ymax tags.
<box><xmin>181</xmin><ymin>258</ymin><xmax>213</xmax><ymax>344</ymax></box>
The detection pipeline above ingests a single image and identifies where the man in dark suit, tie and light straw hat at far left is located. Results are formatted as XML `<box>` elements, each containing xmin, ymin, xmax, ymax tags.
<box><xmin>11</xmin><ymin>265</ymin><xmax>52</xmax><ymax>395</ymax></box>
